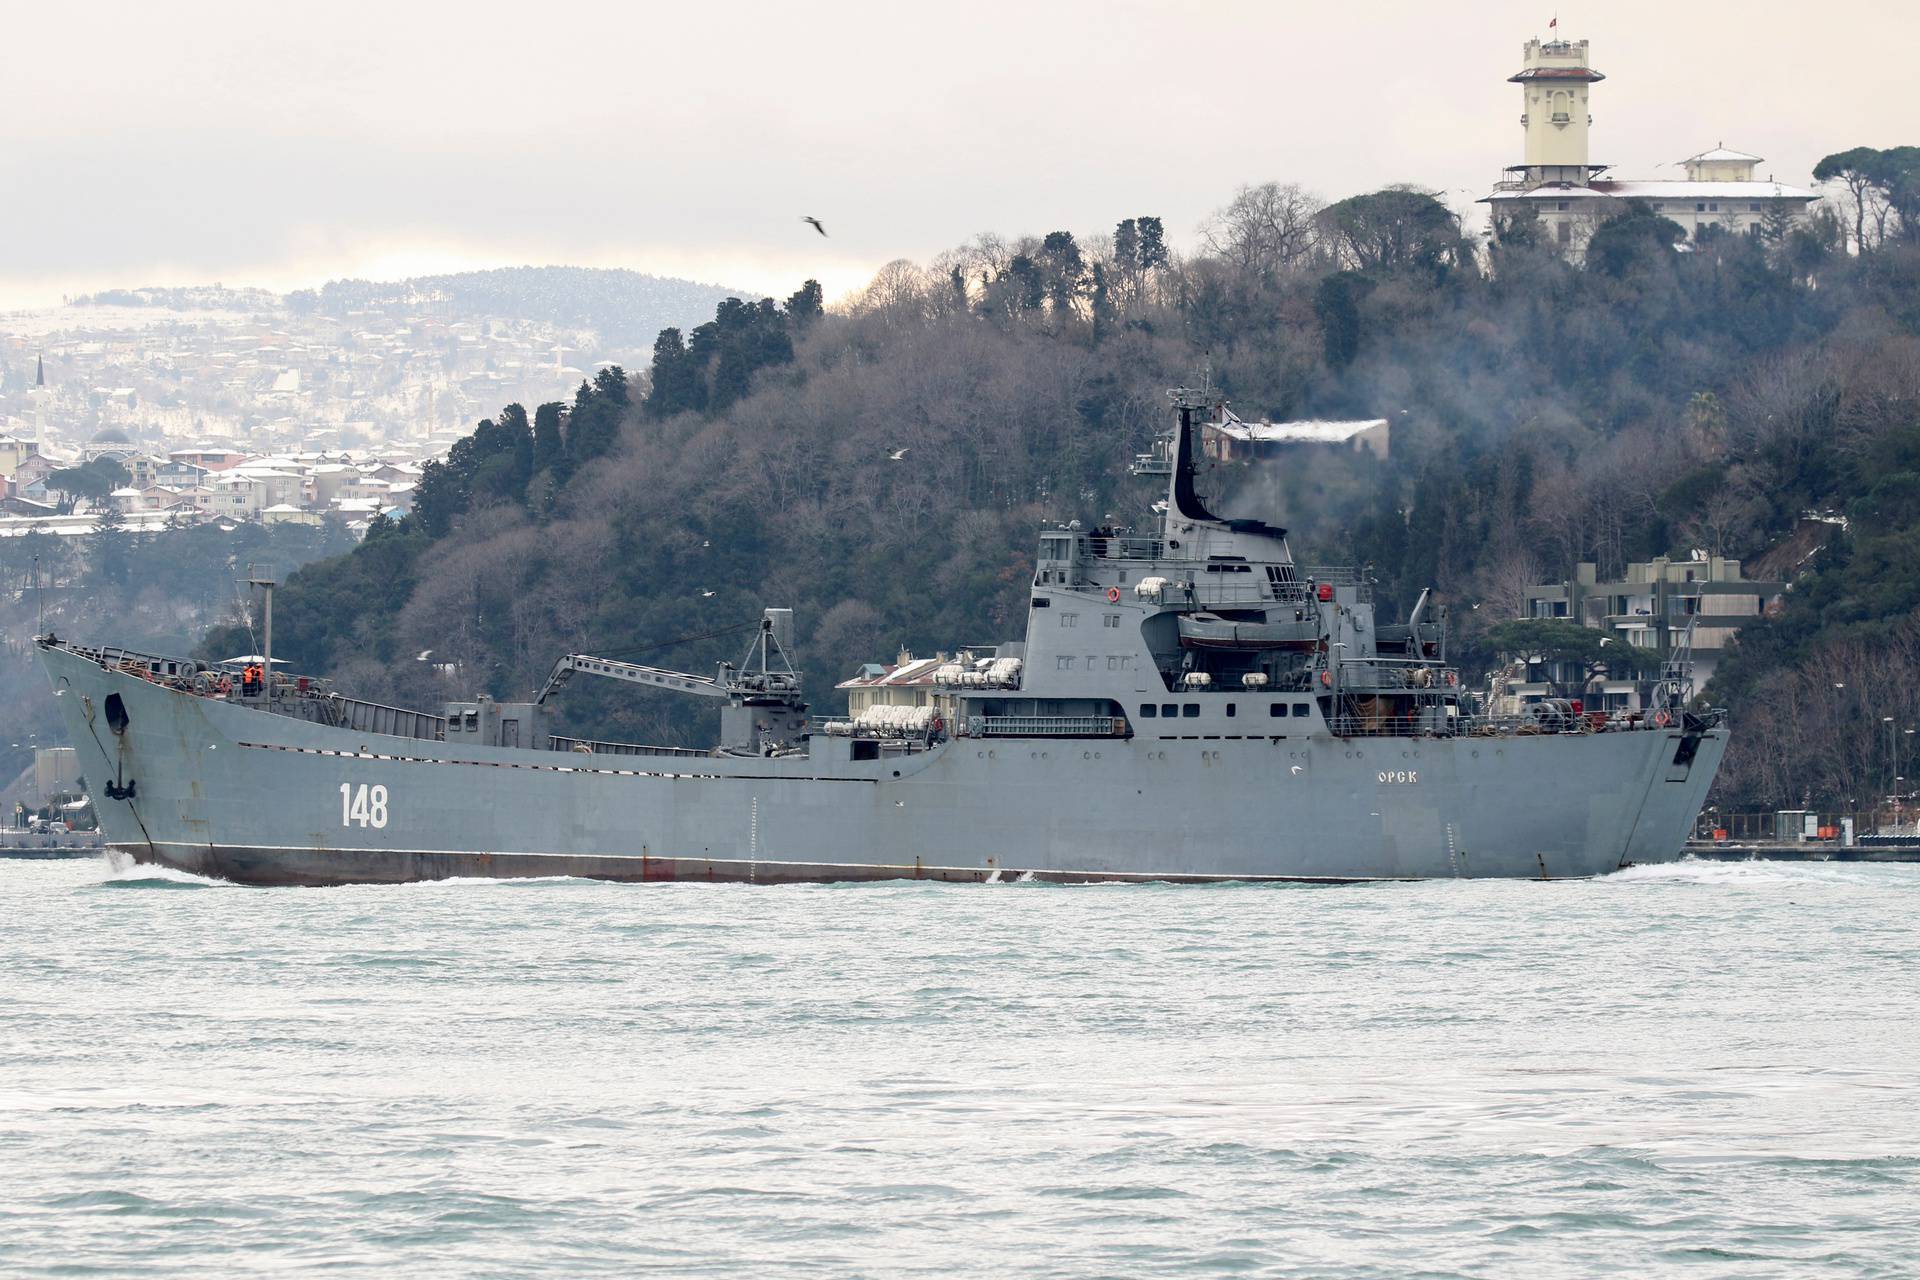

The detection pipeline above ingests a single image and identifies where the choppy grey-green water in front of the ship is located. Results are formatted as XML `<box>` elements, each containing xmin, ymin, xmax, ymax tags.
<box><xmin>0</xmin><ymin>862</ymin><xmax>1920</xmax><ymax>1276</ymax></box>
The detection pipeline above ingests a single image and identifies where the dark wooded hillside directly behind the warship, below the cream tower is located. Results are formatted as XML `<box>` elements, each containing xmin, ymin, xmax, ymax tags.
<box><xmin>215</xmin><ymin>177</ymin><xmax>1920</xmax><ymax>804</ymax></box>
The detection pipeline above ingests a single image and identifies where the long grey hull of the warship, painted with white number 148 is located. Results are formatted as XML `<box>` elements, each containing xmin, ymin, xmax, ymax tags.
<box><xmin>42</xmin><ymin>649</ymin><xmax>1726</xmax><ymax>885</ymax></box>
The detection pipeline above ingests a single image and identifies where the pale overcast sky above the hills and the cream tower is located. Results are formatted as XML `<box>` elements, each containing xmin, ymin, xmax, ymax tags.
<box><xmin>0</xmin><ymin>0</ymin><xmax>1920</xmax><ymax>305</ymax></box>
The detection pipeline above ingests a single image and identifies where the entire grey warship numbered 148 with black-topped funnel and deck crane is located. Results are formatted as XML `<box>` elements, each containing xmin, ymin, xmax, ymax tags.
<box><xmin>38</xmin><ymin>391</ymin><xmax>1728</xmax><ymax>885</ymax></box>
